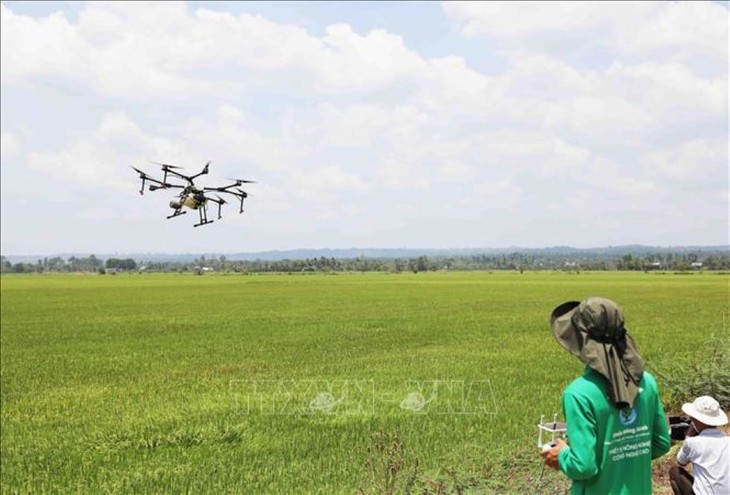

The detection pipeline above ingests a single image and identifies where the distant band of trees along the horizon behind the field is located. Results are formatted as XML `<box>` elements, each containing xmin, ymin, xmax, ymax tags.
<box><xmin>0</xmin><ymin>251</ymin><xmax>730</xmax><ymax>274</ymax></box>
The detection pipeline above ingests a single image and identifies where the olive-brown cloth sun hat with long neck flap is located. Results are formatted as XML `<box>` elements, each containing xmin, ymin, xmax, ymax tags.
<box><xmin>550</xmin><ymin>297</ymin><xmax>644</xmax><ymax>409</ymax></box>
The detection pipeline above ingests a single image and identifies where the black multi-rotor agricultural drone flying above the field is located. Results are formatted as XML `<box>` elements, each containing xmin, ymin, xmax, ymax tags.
<box><xmin>132</xmin><ymin>161</ymin><xmax>254</xmax><ymax>227</ymax></box>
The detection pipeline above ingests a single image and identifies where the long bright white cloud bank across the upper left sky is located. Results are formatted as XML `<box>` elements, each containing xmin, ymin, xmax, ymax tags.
<box><xmin>2</xmin><ymin>2</ymin><xmax>426</xmax><ymax>99</ymax></box>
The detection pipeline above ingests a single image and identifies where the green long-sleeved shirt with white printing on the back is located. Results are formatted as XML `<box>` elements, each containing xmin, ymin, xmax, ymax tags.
<box><xmin>558</xmin><ymin>367</ymin><xmax>671</xmax><ymax>495</ymax></box>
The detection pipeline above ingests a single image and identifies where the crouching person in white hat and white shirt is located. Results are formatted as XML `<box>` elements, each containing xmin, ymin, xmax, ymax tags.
<box><xmin>669</xmin><ymin>395</ymin><xmax>730</xmax><ymax>495</ymax></box>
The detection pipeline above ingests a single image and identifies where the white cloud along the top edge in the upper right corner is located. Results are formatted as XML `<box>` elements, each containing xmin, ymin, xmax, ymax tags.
<box><xmin>443</xmin><ymin>1</ymin><xmax>728</xmax><ymax>72</ymax></box>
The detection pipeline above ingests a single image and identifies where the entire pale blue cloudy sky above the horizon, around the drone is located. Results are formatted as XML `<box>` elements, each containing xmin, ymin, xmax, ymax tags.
<box><xmin>0</xmin><ymin>2</ymin><xmax>729</xmax><ymax>255</ymax></box>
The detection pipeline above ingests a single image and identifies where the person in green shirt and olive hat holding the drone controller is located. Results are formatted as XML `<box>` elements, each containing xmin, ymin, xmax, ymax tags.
<box><xmin>541</xmin><ymin>297</ymin><xmax>671</xmax><ymax>495</ymax></box>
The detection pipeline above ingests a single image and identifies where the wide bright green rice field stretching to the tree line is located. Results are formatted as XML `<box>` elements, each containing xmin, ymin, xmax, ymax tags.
<box><xmin>0</xmin><ymin>272</ymin><xmax>729</xmax><ymax>493</ymax></box>
